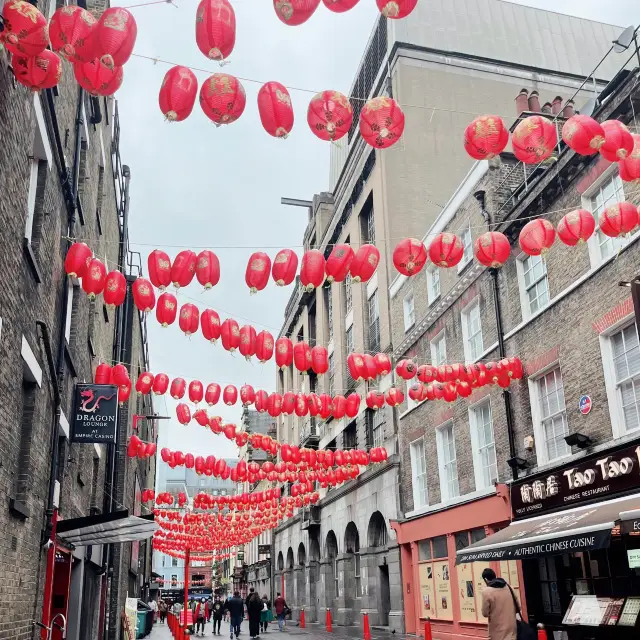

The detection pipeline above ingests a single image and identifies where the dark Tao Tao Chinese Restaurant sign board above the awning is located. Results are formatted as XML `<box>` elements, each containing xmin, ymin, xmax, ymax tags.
<box><xmin>511</xmin><ymin>441</ymin><xmax>640</xmax><ymax>520</ymax></box>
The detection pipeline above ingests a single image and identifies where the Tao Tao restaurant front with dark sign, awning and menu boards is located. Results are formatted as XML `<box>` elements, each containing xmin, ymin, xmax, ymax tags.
<box><xmin>457</xmin><ymin>441</ymin><xmax>640</xmax><ymax>640</ymax></box>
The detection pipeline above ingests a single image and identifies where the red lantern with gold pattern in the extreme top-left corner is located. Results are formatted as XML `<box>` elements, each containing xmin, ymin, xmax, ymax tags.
<box><xmin>0</xmin><ymin>0</ymin><xmax>49</xmax><ymax>56</ymax></box>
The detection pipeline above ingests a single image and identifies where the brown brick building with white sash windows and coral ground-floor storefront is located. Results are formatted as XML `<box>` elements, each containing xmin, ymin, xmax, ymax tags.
<box><xmin>390</xmin><ymin>58</ymin><xmax>640</xmax><ymax>639</ymax></box>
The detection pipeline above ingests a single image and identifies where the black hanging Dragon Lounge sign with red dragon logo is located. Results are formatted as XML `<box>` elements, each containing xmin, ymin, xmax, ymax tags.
<box><xmin>71</xmin><ymin>384</ymin><xmax>118</xmax><ymax>443</ymax></box>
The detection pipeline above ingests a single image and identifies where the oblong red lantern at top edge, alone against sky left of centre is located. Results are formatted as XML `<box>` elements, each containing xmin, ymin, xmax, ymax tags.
<box><xmin>196</xmin><ymin>0</ymin><xmax>236</xmax><ymax>61</ymax></box>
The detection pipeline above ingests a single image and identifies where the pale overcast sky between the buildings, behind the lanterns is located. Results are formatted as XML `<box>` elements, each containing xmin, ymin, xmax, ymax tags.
<box><xmin>116</xmin><ymin>0</ymin><xmax>640</xmax><ymax>457</ymax></box>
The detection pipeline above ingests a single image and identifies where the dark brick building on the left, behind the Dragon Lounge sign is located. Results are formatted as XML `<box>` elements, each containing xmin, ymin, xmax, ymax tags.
<box><xmin>0</xmin><ymin>2</ymin><xmax>154</xmax><ymax>640</ymax></box>
